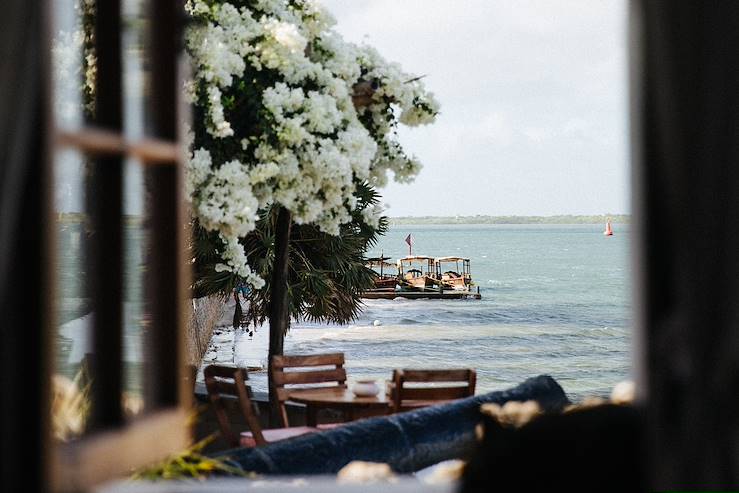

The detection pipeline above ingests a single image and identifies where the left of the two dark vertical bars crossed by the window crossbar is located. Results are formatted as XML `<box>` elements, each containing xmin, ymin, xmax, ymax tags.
<box><xmin>87</xmin><ymin>0</ymin><xmax>124</xmax><ymax>429</ymax></box>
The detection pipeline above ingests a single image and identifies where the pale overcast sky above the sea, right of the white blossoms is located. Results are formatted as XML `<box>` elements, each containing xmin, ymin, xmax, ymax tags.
<box><xmin>322</xmin><ymin>0</ymin><xmax>629</xmax><ymax>216</ymax></box>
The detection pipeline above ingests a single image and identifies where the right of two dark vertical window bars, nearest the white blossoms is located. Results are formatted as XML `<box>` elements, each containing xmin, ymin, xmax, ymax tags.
<box><xmin>146</xmin><ymin>0</ymin><xmax>189</xmax><ymax>408</ymax></box>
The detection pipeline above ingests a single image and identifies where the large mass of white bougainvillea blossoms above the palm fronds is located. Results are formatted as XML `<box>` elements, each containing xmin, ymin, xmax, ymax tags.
<box><xmin>186</xmin><ymin>0</ymin><xmax>439</xmax><ymax>287</ymax></box>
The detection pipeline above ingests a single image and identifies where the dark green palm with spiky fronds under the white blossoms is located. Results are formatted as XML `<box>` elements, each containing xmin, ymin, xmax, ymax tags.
<box><xmin>193</xmin><ymin>183</ymin><xmax>387</xmax><ymax>418</ymax></box>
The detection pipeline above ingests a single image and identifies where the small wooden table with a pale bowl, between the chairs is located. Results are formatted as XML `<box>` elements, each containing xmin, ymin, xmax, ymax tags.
<box><xmin>288</xmin><ymin>387</ymin><xmax>390</xmax><ymax>426</ymax></box>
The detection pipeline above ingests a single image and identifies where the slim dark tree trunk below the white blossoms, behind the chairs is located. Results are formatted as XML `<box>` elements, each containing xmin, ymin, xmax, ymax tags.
<box><xmin>267</xmin><ymin>207</ymin><xmax>292</xmax><ymax>426</ymax></box>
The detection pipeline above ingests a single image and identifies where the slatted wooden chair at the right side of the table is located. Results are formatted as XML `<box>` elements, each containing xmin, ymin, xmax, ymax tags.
<box><xmin>389</xmin><ymin>369</ymin><xmax>477</xmax><ymax>413</ymax></box>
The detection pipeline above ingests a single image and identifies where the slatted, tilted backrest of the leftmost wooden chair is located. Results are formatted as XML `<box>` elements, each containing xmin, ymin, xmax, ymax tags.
<box><xmin>203</xmin><ymin>365</ymin><xmax>267</xmax><ymax>447</ymax></box>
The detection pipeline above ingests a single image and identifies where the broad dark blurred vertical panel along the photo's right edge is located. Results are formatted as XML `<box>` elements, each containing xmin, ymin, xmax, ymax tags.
<box><xmin>630</xmin><ymin>1</ymin><xmax>739</xmax><ymax>491</ymax></box>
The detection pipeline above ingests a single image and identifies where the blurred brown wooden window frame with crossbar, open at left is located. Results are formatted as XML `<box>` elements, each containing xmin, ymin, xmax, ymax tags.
<box><xmin>51</xmin><ymin>0</ymin><xmax>192</xmax><ymax>491</ymax></box>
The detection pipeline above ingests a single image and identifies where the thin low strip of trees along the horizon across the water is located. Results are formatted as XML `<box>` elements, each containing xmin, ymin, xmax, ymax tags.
<box><xmin>390</xmin><ymin>214</ymin><xmax>631</xmax><ymax>225</ymax></box>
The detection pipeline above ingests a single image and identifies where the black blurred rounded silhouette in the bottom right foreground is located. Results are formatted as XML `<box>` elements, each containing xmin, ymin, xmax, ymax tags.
<box><xmin>461</xmin><ymin>404</ymin><xmax>645</xmax><ymax>493</ymax></box>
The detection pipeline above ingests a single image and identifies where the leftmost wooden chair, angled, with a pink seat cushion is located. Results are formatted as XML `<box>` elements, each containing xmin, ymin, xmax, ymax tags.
<box><xmin>203</xmin><ymin>365</ymin><xmax>318</xmax><ymax>447</ymax></box>
